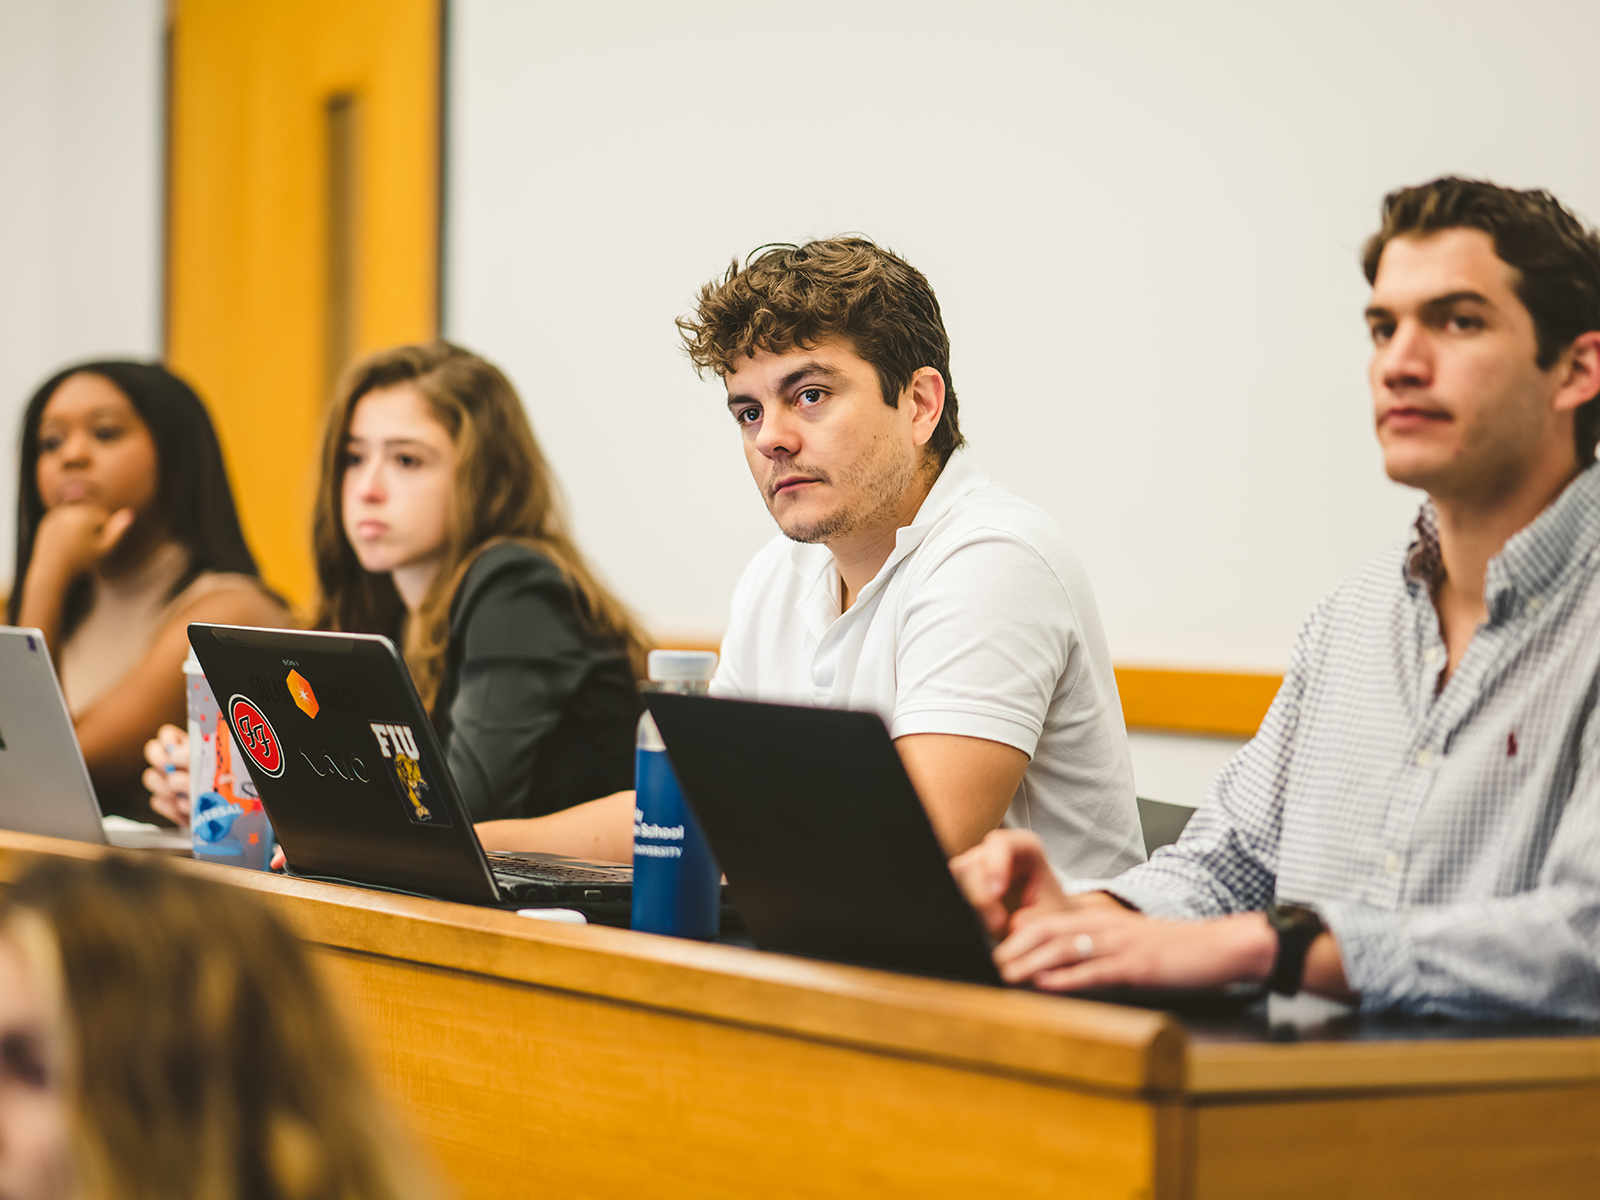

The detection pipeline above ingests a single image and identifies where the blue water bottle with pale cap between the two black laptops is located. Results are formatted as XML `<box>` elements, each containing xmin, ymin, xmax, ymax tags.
<box><xmin>634</xmin><ymin>650</ymin><xmax>722</xmax><ymax>939</ymax></box>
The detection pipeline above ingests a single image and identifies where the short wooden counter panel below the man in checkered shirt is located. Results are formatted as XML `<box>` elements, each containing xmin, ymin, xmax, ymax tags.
<box><xmin>1190</xmin><ymin>1085</ymin><xmax>1600</xmax><ymax>1200</ymax></box>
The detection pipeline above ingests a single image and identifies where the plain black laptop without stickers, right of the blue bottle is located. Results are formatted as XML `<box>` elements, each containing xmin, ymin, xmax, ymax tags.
<box><xmin>645</xmin><ymin>693</ymin><xmax>1000</xmax><ymax>984</ymax></box>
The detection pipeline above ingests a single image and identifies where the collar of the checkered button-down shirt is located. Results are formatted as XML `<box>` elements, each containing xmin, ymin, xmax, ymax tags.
<box><xmin>1403</xmin><ymin>462</ymin><xmax>1600</xmax><ymax>621</ymax></box>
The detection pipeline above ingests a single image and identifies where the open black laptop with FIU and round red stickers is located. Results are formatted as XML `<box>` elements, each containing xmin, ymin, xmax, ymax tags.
<box><xmin>189</xmin><ymin>624</ymin><xmax>634</xmax><ymax>925</ymax></box>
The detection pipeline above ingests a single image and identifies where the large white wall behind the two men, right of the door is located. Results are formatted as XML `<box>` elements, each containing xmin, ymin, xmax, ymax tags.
<box><xmin>446</xmin><ymin>0</ymin><xmax>1600</xmax><ymax>669</ymax></box>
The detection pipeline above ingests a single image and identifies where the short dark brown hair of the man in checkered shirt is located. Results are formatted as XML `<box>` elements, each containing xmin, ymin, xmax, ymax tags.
<box><xmin>1362</xmin><ymin>176</ymin><xmax>1600</xmax><ymax>466</ymax></box>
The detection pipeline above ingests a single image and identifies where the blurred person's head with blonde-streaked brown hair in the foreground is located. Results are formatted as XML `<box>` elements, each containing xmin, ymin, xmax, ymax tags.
<box><xmin>0</xmin><ymin>858</ymin><xmax>432</xmax><ymax>1200</ymax></box>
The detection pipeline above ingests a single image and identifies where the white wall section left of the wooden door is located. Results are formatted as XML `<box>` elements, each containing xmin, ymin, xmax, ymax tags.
<box><xmin>0</xmin><ymin>0</ymin><xmax>166</xmax><ymax>592</ymax></box>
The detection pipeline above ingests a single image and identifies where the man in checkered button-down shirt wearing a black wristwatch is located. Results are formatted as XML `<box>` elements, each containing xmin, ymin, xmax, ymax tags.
<box><xmin>952</xmin><ymin>179</ymin><xmax>1600</xmax><ymax>1019</ymax></box>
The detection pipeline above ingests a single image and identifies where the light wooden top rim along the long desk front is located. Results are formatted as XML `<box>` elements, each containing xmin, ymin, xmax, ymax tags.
<box><xmin>0</xmin><ymin>832</ymin><xmax>1186</xmax><ymax>1094</ymax></box>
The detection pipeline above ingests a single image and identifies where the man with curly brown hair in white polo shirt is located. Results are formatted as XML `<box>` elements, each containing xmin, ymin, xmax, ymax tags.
<box><xmin>480</xmin><ymin>238</ymin><xmax>1144</xmax><ymax>874</ymax></box>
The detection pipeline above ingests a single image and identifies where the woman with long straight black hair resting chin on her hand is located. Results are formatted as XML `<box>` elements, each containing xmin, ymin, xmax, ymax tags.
<box><xmin>6</xmin><ymin>362</ymin><xmax>288</xmax><ymax>818</ymax></box>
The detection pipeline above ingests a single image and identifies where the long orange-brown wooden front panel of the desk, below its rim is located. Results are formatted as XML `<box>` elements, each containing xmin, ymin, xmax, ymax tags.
<box><xmin>320</xmin><ymin>949</ymin><xmax>1155</xmax><ymax>1200</ymax></box>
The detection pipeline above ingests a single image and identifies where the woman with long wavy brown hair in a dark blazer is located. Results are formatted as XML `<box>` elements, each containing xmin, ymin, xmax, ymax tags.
<box><xmin>144</xmin><ymin>342</ymin><xmax>648</xmax><ymax>821</ymax></box>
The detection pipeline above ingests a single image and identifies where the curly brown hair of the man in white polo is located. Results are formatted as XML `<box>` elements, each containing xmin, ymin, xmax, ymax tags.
<box><xmin>677</xmin><ymin>237</ymin><xmax>966</xmax><ymax>469</ymax></box>
